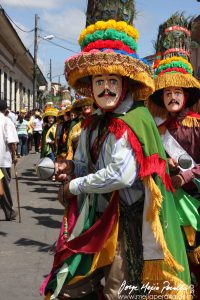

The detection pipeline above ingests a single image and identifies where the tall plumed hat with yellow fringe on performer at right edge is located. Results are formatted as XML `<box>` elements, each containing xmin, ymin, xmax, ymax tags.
<box><xmin>149</xmin><ymin>13</ymin><xmax>200</xmax><ymax>115</ymax></box>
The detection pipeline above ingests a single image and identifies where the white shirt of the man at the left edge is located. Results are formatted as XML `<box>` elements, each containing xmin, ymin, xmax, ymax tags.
<box><xmin>0</xmin><ymin>112</ymin><xmax>19</xmax><ymax>168</ymax></box>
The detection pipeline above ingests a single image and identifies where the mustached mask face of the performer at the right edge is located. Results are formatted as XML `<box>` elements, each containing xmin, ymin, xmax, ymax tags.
<box><xmin>163</xmin><ymin>87</ymin><xmax>185</xmax><ymax>113</ymax></box>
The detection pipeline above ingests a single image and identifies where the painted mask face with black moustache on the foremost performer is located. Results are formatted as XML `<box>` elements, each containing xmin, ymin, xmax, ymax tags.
<box><xmin>92</xmin><ymin>74</ymin><xmax>122</xmax><ymax>110</ymax></box>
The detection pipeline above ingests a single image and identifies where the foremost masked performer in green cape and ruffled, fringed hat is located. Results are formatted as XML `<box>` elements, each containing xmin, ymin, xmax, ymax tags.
<box><xmin>41</xmin><ymin>11</ymin><xmax>190</xmax><ymax>299</ymax></box>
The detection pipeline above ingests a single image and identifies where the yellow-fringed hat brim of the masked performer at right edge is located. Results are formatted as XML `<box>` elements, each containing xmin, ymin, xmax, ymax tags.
<box><xmin>150</xmin><ymin>73</ymin><xmax>200</xmax><ymax>107</ymax></box>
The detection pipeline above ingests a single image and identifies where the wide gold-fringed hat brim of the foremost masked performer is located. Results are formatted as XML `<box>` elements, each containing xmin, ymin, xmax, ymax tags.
<box><xmin>65</xmin><ymin>52</ymin><xmax>154</xmax><ymax>99</ymax></box>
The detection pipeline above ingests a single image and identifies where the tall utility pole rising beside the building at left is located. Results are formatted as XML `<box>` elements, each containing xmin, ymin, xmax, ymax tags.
<box><xmin>33</xmin><ymin>14</ymin><xmax>39</xmax><ymax>109</ymax></box>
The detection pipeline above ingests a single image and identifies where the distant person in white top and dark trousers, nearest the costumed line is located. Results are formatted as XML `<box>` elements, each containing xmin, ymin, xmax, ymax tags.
<box><xmin>32</xmin><ymin>111</ymin><xmax>43</xmax><ymax>153</ymax></box>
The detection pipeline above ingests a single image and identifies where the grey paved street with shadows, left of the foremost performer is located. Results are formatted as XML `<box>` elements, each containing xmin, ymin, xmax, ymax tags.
<box><xmin>0</xmin><ymin>154</ymin><xmax>63</xmax><ymax>300</ymax></box>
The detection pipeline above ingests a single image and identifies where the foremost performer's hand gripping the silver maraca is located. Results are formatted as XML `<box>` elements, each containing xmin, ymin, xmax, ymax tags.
<box><xmin>55</xmin><ymin>159</ymin><xmax>74</xmax><ymax>181</ymax></box>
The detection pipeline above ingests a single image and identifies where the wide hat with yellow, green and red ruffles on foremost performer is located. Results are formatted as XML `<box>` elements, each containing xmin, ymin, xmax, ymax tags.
<box><xmin>65</xmin><ymin>20</ymin><xmax>154</xmax><ymax>100</ymax></box>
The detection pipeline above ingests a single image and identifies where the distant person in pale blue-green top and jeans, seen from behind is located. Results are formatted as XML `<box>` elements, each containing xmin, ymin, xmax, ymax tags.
<box><xmin>16</xmin><ymin>109</ymin><xmax>28</xmax><ymax>157</ymax></box>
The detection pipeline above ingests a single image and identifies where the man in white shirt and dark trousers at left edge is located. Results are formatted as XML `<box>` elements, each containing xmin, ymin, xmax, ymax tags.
<box><xmin>0</xmin><ymin>100</ymin><xmax>19</xmax><ymax>221</ymax></box>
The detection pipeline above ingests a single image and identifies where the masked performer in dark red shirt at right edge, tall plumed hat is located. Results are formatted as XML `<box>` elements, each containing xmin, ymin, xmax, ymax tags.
<box><xmin>149</xmin><ymin>13</ymin><xmax>200</xmax><ymax>296</ymax></box>
